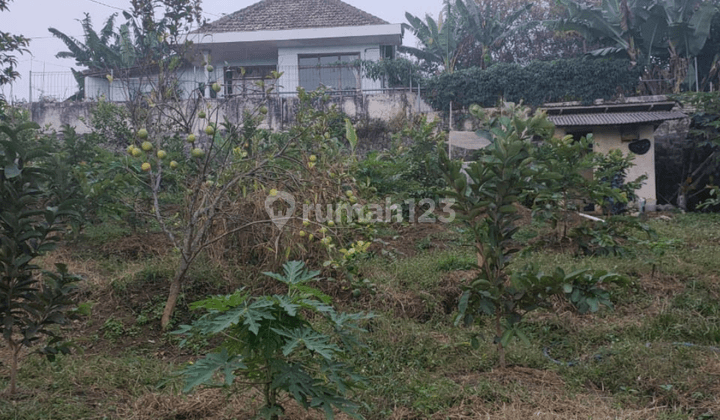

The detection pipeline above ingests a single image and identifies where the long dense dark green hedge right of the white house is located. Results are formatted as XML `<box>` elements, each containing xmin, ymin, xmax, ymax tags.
<box><xmin>423</xmin><ymin>59</ymin><xmax>641</xmax><ymax>110</ymax></box>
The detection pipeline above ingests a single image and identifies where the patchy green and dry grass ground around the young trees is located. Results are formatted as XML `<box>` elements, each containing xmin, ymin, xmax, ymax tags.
<box><xmin>0</xmin><ymin>214</ymin><xmax>720</xmax><ymax>420</ymax></box>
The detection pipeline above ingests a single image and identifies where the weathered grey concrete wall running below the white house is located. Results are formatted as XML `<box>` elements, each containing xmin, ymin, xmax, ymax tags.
<box><xmin>31</xmin><ymin>90</ymin><xmax>434</xmax><ymax>134</ymax></box>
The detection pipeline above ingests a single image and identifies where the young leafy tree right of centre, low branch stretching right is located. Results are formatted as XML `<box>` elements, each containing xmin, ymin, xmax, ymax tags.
<box><xmin>441</xmin><ymin>103</ymin><xmax>620</xmax><ymax>368</ymax></box>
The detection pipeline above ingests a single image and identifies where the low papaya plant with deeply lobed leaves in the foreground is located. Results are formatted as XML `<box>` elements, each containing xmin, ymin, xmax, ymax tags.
<box><xmin>174</xmin><ymin>261</ymin><xmax>372</xmax><ymax>420</ymax></box>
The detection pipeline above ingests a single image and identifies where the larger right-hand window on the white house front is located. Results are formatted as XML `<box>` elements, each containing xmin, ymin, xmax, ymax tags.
<box><xmin>298</xmin><ymin>53</ymin><xmax>360</xmax><ymax>91</ymax></box>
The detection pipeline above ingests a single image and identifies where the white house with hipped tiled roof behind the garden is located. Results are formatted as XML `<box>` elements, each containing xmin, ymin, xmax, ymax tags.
<box><xmin>190</xmin><ymin>0</ymin><xmax>402</xmax><ymax>96</ymax></box>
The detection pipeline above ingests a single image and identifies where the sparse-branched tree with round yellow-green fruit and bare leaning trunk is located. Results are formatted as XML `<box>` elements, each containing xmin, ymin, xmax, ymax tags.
<box><xmin>127</xmin><ymin>82</ymin><xmax>354</xmax><ymax>328</ymax></box>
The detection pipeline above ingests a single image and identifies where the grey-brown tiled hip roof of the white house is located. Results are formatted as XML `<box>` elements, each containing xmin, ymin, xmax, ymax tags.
<box><xmin>197</xmin><ymin>0</ymin><xmax>388</xmax><ymax>33</ymax></box>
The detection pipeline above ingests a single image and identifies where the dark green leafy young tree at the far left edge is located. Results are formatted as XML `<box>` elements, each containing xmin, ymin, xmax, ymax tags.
<box><xmin>0</xmin><ymin>123</ymin><xmax>79</xmax><ymax>394</ymax></box>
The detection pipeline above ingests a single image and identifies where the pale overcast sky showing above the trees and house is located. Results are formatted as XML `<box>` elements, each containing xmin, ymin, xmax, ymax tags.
<box><xmin>0</xmin><ymin>0</ymin><xmax>442</xmax><ymax>100</ymax></box>
